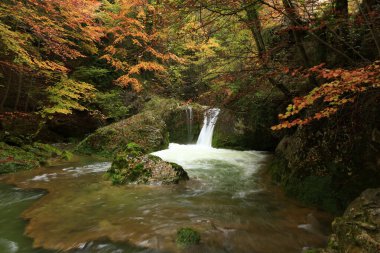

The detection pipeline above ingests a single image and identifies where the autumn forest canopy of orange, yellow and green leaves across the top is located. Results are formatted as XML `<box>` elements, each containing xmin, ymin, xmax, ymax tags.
<box><xmin>0</xmin><ymin>0</ymin><xmax>380</xmax><ymax>130</ymax></box>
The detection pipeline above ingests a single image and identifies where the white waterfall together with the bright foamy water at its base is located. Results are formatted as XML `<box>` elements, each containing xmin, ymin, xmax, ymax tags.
<box><xmin>152</xmin><ymin>108</ymin><xmax>267</xmax><ymax>187</ymax></box>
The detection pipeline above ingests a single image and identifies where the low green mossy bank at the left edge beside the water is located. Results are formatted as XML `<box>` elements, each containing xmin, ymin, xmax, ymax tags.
<box><xmin>0</xmin><ymin>142</ymin><xmax>72</xmax><ymax>174</ymax></box>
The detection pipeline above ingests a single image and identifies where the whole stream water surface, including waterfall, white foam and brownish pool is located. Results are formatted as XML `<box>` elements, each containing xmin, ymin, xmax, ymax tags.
<box><xmin>0</xmin><ymin>110</ymin><xmax>329</xmax><ymax>253</ymax></box>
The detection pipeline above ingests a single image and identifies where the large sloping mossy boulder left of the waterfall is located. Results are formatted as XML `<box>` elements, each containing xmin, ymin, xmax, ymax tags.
<box><xmin>76</xmin><ymin>97</ymin><xmax>203</xmax><ymax>157</ymax></box>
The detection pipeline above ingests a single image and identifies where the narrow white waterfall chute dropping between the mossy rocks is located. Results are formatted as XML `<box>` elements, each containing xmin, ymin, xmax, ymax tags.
<box><xmin>197</xmin><ymin>108</ymin><xmax>220</xmax><ymax>147</ymax></box>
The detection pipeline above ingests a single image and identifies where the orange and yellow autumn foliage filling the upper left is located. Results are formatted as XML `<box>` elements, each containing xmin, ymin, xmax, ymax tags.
<box><xmin>0</xmin><ymin>0</ymin><xmax>178</xmax><ymax>117</ymax></box>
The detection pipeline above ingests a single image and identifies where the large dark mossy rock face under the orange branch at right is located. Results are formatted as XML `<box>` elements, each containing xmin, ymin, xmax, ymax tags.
<box><xmin>270</xmin><ymin>94</ymin><xmax>380</xmax><ymax>214</ymax></box>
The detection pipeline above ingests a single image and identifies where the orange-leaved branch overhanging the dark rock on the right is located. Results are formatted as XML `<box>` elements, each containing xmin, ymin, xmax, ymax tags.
<box><xmin>272</xmin><ymin>61</ymin><xmax>380</xmax><ymax>130</ymax></box>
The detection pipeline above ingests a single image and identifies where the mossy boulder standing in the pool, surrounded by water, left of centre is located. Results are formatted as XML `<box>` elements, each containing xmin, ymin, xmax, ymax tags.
<box><xmin>106</xmin><ymin>143</ymin><xmax>189</xmax><ymax>185</ymax></box>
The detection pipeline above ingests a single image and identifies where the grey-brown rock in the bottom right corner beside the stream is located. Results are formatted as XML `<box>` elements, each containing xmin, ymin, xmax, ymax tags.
<box><xmin>323</xmin><ymin>188</ymin><xmax>380</xmax><ymax>253</ymax></box>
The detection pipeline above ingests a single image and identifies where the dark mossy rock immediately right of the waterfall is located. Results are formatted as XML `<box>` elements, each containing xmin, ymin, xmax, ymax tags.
<box><xmin>213</xmin><ymin>91</ymin><xmax>284</xmax><ymax>151</ymax></box>
